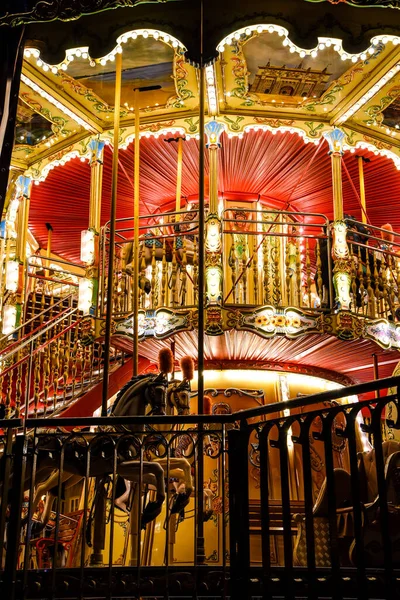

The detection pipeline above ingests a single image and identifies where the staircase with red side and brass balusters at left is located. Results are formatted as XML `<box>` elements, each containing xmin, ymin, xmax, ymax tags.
<box><xmin>0</xmin><ymin>291</ymin><xmax>132</xmax><ymax>418</ymax></box>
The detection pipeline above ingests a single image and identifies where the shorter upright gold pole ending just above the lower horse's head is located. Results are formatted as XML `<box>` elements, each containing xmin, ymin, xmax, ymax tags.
<box><xmin>133</xmin><ymin>89</ymin><xmax>140</xmax><ymax>375</ymax></box>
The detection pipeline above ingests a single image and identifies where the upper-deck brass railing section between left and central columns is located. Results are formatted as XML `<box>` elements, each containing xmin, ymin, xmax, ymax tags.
<box><xmin>100</xmin><ymin>210</ymin><xmax>198</xmax><ymax>317</ymax></box>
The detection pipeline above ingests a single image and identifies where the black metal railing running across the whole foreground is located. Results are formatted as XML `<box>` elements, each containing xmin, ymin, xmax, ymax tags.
<box><xmin>0</xmin><ymin>377</ymin><xmax>400</xmax><ymax>600</ymax></box>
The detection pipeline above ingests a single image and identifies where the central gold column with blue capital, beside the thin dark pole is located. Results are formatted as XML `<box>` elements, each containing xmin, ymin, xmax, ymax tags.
<box><xmin>204</xmin><ymin>120</ymin><xmax>225</xmax><ymax>312</ymax></box>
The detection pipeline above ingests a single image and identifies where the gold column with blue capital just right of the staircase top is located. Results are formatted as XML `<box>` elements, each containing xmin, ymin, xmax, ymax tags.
<box><xmin>81</xmin><ymin>139</ymin><xmax>104</xmax><ymax>316</ymax></box>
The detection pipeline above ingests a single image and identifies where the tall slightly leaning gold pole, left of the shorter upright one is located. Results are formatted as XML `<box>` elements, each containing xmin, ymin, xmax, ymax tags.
<box><xmin>101</xmin><ymin>54</ymin><xmax>122</xmax><ymax>417</ymax></box>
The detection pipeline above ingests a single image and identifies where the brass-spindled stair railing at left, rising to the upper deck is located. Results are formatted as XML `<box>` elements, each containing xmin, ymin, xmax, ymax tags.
<box><xmin>0</xmin><ymin>259</ymin><xmax>122</xmax><ymax>418</ymax></box>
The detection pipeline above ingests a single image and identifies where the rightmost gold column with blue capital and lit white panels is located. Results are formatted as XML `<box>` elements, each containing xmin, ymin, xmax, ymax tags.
<box><xmin>324</xmin><ymin>127</ymin><xmax>351</xmax><ymax>310</ymax></box>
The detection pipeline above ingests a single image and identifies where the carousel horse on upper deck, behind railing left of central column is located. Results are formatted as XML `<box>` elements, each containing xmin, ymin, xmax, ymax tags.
<box><xmin>121</xmin><ymin>211</ymin><xmax>198</xmax><ymax>275</ymax></box>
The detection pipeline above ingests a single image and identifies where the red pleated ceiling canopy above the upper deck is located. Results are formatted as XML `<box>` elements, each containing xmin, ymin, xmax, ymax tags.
<box><xmin>29</xmin><ymin>131</ymin><xmax>400</xmax><ymax>262</ymax></box>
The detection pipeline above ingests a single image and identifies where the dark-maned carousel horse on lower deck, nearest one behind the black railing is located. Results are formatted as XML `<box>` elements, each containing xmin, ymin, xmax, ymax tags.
<box><xmin>0</xmin><ymin>350</ymin><xmax>178</xmax><ymax>540</ymax></box>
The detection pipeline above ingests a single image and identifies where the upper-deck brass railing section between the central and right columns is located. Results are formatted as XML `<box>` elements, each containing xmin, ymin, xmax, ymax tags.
<box><xmin>223</xmin><ymin>209</ymin><xmax>332</xmax><ymax>310</ymax></box>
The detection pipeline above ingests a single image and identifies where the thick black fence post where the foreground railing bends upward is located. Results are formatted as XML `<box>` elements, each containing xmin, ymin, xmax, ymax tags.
<box><xmin>228</xmin><ymin>423</ymin><xmax>250</xmax><ymax>600</ymax></box>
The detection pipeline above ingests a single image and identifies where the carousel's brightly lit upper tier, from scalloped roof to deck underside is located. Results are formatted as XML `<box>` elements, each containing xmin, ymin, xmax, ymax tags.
<box><xmin>3</xmin><ymin>3</ymin><xmax>400</xmax><ymax>396</ymax></box>
